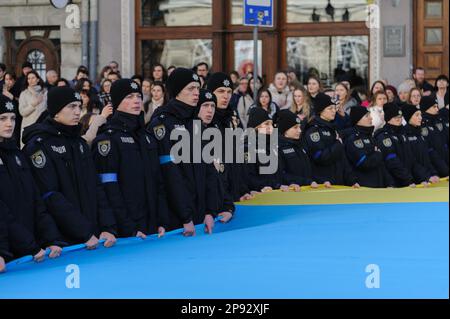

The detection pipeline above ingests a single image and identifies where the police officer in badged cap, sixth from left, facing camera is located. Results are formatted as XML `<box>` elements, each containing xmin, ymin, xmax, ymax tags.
<box><xmin>207</xmin><ymin>72</ymin><xmax>253</xmax><ymax>201</ymax></box>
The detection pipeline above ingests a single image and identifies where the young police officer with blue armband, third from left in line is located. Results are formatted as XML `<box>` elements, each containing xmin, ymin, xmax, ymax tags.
<box><xmin>92</xmin><ymin>79</ymin><xmax>169</xmax><ymax>239</ymax></box>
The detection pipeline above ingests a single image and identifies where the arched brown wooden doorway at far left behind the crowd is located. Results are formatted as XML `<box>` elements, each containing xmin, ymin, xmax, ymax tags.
<box><xmin>16</xmin><ymin>37</ymin><xmax>60</xmax><ymax>79</ymax></box>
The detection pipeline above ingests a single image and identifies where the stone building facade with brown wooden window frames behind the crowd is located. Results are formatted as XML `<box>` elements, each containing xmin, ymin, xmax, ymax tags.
<box><xmin>0</xmin><ymin>0</ymin><xmax>449</xmax><ymax>85</ymax></box>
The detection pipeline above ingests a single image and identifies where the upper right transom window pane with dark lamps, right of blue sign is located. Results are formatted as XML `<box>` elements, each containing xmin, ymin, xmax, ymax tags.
<box><xmin>286</xmin><ymin>0</ymin><xmax>368</xmax><ymax>23</ymax></box>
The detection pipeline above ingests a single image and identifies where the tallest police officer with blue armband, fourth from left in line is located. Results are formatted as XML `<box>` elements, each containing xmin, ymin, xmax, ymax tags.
<box><xmin>149</xmin><ymin>68</ymin><xmax>218</xmax><ymax>236</ymax></box>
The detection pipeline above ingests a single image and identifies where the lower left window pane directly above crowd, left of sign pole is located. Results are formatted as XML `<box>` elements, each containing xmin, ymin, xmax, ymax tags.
<box><xmin>141</xmin><ymin>39</ymin><xmax>212</xmax><ymax>77</ymax></box>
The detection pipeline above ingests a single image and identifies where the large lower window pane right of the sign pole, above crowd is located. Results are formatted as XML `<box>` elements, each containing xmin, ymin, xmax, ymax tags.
<box><xmin>287</xmin><ymin>36</ymin><xmax>369</xmax><ymax>86</ymax></box>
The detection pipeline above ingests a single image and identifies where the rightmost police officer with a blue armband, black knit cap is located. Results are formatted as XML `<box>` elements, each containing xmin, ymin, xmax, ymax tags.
<box><xmin>374</xmin><ymin>103</ymin><xmax>416</xmax><ymax>187</ymax></box>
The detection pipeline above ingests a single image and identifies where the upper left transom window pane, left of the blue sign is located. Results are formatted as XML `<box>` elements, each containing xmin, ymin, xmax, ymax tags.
<box><xmin>141</xmin><ymin>0</ymin><xmax>212</xmax><ymax>27</ymax></box>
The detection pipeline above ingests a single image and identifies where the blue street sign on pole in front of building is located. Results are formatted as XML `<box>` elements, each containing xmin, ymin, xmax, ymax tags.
<box><xmin>244</xmin><ymin>0</ymin><xmax>273</xmax><ymax>27</ymax></box>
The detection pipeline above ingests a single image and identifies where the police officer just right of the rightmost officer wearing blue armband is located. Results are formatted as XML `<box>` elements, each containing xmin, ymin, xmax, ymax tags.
<box><xmin>402</xmin><ymin>104</ymin><xmax>439</xmax><ymax>186</ymax></box>
